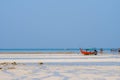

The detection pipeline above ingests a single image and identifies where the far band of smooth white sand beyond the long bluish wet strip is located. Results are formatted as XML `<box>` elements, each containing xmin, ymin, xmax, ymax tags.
<box><xmin>0</xmin><ymin>53</ymin><xmax>120</xmax><ymax>63</ymax></box>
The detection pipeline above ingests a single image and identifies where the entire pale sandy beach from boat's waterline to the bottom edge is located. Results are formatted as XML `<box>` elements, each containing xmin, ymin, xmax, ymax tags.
<box><xmin>0</xmin><ymin>53</ymin><xmax>120</xmax><ymax>80</ymax></box>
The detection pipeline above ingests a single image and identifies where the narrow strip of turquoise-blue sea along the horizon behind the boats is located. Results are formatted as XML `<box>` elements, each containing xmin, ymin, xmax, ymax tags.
<box><xmin>0</xmin><ymin>48</ymin><xmax>117</xmax><ymax>53</ymax></box>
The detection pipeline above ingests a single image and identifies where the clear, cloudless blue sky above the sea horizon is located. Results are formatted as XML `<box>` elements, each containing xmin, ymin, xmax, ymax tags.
<box><xmin>0</xmin><ymin>0</ymin><xmax>120</xmax><ymax>48</ymax></box>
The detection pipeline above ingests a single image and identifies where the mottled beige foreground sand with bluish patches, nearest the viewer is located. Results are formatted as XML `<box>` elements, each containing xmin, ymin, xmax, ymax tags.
<box><xmin>0</xmin><ymin>63</ymin><xmax>120</xmax><ymax>80</ymax></box>
